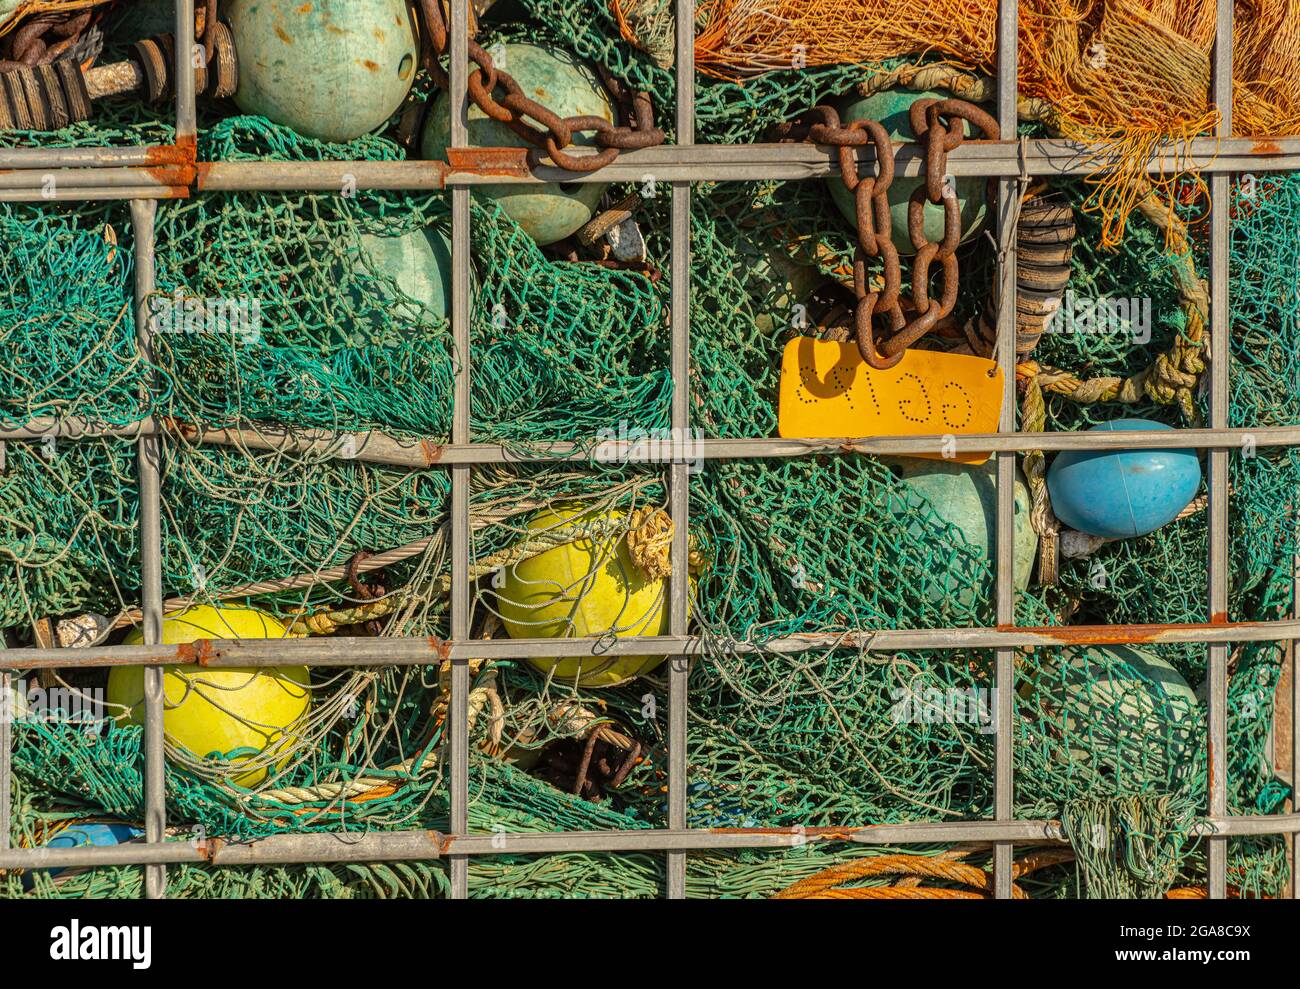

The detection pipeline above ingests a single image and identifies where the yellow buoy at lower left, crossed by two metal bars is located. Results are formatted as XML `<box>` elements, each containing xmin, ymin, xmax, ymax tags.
<box><xmin>108</xmin><ymin>606</ymin><xmax>312</xmax><ymax>786</ymax></box>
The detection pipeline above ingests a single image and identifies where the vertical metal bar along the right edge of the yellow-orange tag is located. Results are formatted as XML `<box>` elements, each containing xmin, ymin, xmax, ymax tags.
<box><xmin>993</xmin><ymin>0</ymin><xmax>1021</xmax><ymax>899</ymax></box>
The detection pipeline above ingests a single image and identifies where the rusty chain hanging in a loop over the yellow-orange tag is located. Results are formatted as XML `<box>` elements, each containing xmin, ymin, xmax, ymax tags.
<box><xmin>776</xmin><ymin>99</ymin><xmax>1001</xmax><ymax>370</ymax></box>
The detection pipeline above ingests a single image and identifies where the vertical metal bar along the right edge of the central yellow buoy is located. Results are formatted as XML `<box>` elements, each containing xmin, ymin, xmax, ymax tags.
<box><xmin>667</xmin><ymin>0</ymin><xmax>696</xmax><ymax>899</ymax></box>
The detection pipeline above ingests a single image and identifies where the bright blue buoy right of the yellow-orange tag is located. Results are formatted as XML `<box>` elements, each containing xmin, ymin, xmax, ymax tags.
<box><xmin>1048</xmin><ymin>418</ymin><xmax>1201</xmax><ymax>539</ymax></box>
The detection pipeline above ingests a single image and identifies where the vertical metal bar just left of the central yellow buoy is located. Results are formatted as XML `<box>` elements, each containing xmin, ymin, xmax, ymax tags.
<box><xmin>449</xmin><ymin>0</ymin><xmax>472</xmax><ymax>899</ymax></box>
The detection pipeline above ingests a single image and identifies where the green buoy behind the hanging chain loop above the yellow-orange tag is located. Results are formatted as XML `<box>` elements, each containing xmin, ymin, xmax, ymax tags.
<box><xmin>827</xmin><ymin>90</ymin><xmax>988</xmax><ymax>255</ymax></box>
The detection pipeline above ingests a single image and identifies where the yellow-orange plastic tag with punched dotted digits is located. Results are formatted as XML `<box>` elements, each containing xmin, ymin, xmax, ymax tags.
<box><xmin>777</xmin><ymin>337</ymin><xmax>1002</xmax><ymax>464</ymax></box>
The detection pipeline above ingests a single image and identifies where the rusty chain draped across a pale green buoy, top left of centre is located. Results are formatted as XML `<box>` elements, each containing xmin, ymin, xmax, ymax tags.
<box><xmin>417</xmin><ymin>0</ymin><xmax>663</xmax><ymax>172</ymax></box>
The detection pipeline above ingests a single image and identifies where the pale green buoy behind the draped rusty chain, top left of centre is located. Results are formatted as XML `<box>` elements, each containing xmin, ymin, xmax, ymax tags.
<box><xmin>421</xmin><ymin>44</ymin><xmax>615</xmax><ymax>247</ymax></box>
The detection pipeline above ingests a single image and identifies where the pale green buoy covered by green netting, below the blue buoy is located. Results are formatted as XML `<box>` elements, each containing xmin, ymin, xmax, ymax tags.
<box><xmin>1035</xmin><ymin>646</ymin><xmax>1199</xmax><ymax>789</ymax></box>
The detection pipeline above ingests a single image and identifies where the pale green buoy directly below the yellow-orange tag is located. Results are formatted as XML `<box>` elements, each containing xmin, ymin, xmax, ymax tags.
<box><xmin>894</xmin><ymin>457</ymin><xmax>1039</xmax><ymax>607</ymax></box>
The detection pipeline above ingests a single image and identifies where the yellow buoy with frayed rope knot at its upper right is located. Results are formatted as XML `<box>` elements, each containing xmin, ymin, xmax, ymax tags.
<box><xmin>497</xmin><ymin>506</ymin><xmax>668</xmax><ymax>687</ymax></box>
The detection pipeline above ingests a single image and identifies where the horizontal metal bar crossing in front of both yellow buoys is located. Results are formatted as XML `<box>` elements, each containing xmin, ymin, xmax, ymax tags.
<box><xmin>0</xmin><ymin>619</ymin><xmax>1300</xmax><ymax>669</ymax></box>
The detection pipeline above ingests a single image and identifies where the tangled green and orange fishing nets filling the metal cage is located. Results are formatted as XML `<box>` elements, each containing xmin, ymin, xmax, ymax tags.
<box><xmin>0</xmin><ymin>0</ymin><xmax>1300</xmax><ymax>897</ymax></box>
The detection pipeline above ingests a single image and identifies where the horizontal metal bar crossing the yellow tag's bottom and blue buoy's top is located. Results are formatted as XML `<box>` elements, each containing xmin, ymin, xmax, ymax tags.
<box><xmin>0</xmin><ymin>418</ymin><xmax>1300</xmax><ymax>467</ymax></box>
